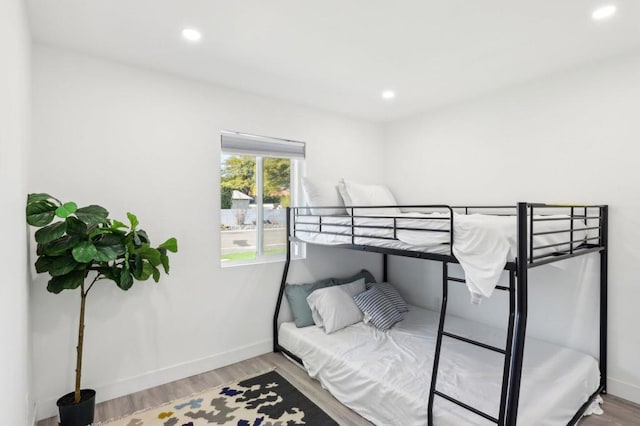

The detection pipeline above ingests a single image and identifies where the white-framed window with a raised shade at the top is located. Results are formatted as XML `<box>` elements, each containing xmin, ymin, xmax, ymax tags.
<box><xmin>220</xmin><ymin>132</ymin><xmax>305</xmax><ymax>266</ymax></box>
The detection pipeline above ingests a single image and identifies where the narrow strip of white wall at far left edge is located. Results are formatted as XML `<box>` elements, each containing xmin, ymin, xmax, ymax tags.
<box><xmin>0</xmin><ymin>0</ymin><xmax>33</xmax><ymax>425</ymax></box>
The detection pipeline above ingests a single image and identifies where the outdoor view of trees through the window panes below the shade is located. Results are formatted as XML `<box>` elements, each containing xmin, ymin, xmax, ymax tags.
<box><xmin>220</xmin><ymin>154</ymin><xmax>292</xmax><ymax>261</ymax></box>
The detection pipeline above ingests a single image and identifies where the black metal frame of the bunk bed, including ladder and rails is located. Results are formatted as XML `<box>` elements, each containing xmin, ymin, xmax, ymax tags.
<box><xmin>273</xmin><ymin>202</ymin><xmax>608</xmax><ymax>426</ymax></box>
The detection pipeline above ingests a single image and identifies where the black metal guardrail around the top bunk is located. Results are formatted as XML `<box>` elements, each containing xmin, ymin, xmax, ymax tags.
<box><xmin>289</xmin><ymin>203</ymin><xmax>604</xmax><ymax>269</ymax></box>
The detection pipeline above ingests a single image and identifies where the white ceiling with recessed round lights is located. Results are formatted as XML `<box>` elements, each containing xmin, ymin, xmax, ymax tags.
<box><xmin>28</xmin><ymin>0</ymin><xmax>640</xmax><ymax>122</ymax></box>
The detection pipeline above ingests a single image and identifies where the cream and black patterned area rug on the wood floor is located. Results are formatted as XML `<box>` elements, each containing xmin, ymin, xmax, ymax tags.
<box><xmin>99</xmin><ymin>371</ymin><xmax>338</xmax><ymax>426</ymax></box>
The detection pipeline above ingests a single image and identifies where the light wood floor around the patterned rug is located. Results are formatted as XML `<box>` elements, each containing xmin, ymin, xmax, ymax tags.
<box><xmin>38</xmin><ymin>353</ymin><xmax>640</xmax><ymax>426</ymax></box>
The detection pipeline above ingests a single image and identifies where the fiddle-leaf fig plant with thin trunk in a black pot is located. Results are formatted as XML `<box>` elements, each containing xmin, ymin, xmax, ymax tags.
<box><xmin>27</xmin><ymin>194</ymin><xmax>178</xmax><ymax>426</ymax></box>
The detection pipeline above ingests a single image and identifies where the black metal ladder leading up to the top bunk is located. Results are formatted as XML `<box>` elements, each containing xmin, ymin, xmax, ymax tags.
<box><xmin>428</xmin><ymin>262</ymin><xmax>519</xmax><ymax>425</ymax></box>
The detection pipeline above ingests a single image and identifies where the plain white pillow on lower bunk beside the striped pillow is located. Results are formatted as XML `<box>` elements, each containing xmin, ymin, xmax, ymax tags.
<box><xmin>307</xmin><ymin>278</ymin><xmax>366</xmax><ymax>334</ymax></box>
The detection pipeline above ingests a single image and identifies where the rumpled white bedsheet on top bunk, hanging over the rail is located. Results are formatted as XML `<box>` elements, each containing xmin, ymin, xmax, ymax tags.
<box><xmin>296</xmin><ymin>213</ymin><xmax>587</xmax><ymax>303</ymax></box>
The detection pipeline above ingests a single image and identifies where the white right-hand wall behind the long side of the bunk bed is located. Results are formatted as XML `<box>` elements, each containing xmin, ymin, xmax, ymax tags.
<box><xmin>385</xmin><ymin>50</ymin><xmax>640</xmax><ymax>402</ymax></box>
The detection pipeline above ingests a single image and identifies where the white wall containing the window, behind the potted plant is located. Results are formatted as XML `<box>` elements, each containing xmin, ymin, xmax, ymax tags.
<box><xmin>29</xmin><ymin>47</ymin><xmax>383</xmax><ymax>417</ymax></box>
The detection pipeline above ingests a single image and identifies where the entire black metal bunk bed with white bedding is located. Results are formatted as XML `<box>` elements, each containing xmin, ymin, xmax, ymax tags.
<box><xmin>273</xmin><ymin>202</ymin><xmax>608</xmax><ymax>425</ymax></box>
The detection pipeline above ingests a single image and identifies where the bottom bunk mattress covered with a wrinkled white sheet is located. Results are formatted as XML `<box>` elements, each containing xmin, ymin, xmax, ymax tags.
<box><xmin>279</xmin><ymin>306</ymin><xmax>600</xmax><ymax>425</ymax></box>
